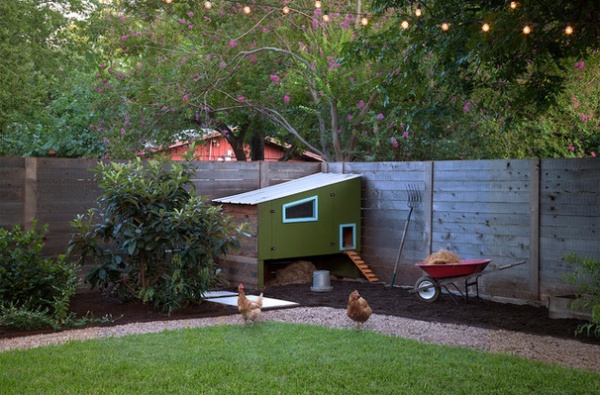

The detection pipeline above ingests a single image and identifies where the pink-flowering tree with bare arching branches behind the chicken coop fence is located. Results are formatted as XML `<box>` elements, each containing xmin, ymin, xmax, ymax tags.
<box><xmin>78</xmin><ymin>0</ymin><xmax>406</xmax><ymax>161</ymax></box>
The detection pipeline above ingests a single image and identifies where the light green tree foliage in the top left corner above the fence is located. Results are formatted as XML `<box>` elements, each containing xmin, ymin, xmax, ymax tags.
<box><xmin>0</xmin><ymin>0</ymin><xmax>99</xmax><ymax>156</ymax></box>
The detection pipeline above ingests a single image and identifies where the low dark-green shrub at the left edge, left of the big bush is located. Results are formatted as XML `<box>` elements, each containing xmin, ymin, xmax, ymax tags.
<box><xmin>0</xmin><ymin>222</ymin><xmax>78</xmax><ymax>327</ymax></box>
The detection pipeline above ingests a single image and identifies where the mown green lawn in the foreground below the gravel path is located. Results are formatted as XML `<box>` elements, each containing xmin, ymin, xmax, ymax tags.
<box><xmin>0</xmin><ymin>322</ymin><xmax>600</xmax><ymax>395</ymax></box>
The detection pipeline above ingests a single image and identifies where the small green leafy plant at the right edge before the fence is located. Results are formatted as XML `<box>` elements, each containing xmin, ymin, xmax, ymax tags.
<box><xmin>565</xmin><ymin>253</ymin><xmax>600</xmax><ymax>338</ymax></box>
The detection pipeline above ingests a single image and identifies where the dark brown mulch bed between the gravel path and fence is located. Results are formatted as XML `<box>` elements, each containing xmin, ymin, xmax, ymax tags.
<box><xmin>0</xmin><ymin>281</ymin><xmax>600</xmax><ymax>344</ymax></box>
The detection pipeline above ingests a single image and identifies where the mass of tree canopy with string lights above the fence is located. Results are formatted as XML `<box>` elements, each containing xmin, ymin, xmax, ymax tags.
<box><xmin>0</xmin><ymin>0</ymin><xmax>600</xmax><ymax>161</ymax></box>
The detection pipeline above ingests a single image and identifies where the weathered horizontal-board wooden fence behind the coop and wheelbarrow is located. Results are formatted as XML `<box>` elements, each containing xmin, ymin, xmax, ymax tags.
<box><xmin>0</xmin><ymin>158</ymin><xmax>600</xmax><ymax>301</ymax></box>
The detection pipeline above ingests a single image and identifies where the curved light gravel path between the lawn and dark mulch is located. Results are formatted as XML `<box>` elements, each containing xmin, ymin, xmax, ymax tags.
<box><xmin>0</xmin><ymin>307</ymin><xmax>600</xmax><ymax>373</ymax></box>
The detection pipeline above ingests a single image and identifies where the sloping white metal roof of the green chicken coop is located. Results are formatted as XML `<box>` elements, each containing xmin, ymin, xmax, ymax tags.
<box><xmin>213</xmin><ymin>173</ymin><xmax>360</xmax><ymax>204</ymax></box>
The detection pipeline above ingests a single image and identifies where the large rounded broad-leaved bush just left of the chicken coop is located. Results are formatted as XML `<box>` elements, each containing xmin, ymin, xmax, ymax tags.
<box><xmin>68</xmin><ymin>154</ymin><xmax>243</xmax><ymax>311</ymax></box>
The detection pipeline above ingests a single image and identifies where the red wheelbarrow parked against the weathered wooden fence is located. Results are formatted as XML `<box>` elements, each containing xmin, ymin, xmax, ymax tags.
<box><xmin>414</xmin><ymin>259</ymin><xmax>526</xmax><ymax>303</ymax></box>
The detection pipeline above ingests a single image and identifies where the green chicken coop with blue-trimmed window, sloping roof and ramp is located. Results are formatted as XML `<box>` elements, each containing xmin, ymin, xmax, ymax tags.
<box><xmin>213</xmin><ymin>173</ymin><xmax>377</xmax><ymax>287</ymax></box>
